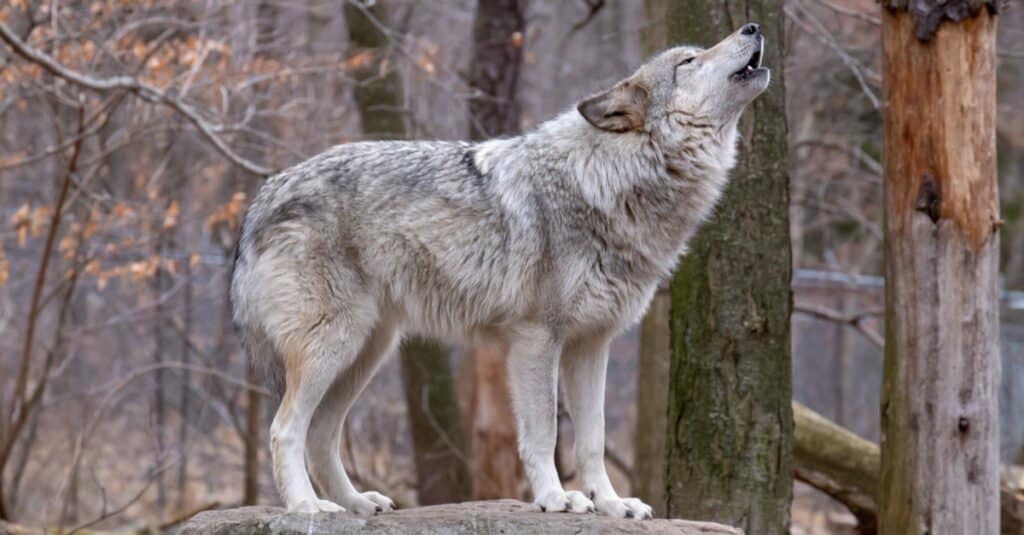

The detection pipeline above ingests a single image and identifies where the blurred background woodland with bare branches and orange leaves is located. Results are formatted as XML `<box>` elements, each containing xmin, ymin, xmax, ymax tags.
<box><xmin>0</xmin><ymin>0</ymin><xmax>1024</xmax><ymax>533</ymax></box>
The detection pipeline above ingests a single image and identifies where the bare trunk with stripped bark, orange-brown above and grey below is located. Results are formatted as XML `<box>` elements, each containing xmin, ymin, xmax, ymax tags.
<box><xmin>879</xmin><ymin>0</ymin><xmax>999</xmax><ymax>535</ymax></box>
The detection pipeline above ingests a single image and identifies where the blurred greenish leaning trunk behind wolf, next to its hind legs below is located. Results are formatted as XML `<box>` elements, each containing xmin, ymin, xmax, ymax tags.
<box><xmin>344</xmin><ymin>2</ymin><xmax>472</xmax><ymax>505</ymax></box>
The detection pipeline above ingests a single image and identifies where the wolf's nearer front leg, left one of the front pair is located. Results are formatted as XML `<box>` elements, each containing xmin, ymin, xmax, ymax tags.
<box><xmin>508</xmin><ymin>327</ymin><xmax>594</xmax><ymax>512</ymax></box>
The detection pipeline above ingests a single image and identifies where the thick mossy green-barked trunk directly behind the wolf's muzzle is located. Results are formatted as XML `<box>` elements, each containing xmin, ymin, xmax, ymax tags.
<box><xmin>666</xmin><ymin>0</ymin><xmax>793</xmax><ymax>534</ymax></box>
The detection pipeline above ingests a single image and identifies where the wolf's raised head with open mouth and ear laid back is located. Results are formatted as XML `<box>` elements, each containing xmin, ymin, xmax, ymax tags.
<box><xmin>577</xmin><ymin>24</ymin><xmax>771</xmax><ymax>135</ymax></box>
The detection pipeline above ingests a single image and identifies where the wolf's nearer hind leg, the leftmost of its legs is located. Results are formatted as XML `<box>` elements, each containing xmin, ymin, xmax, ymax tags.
<box><xmin>270</xmin><ymin>318</ymin><xmax>369</xmax><ymax>512</ymax></box>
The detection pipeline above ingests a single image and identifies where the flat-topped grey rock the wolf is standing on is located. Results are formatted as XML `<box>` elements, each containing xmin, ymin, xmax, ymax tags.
<box><xmin>178</xmin><ymin>500</ymin><xmax>742</xmax><ymax>535</ymax></box>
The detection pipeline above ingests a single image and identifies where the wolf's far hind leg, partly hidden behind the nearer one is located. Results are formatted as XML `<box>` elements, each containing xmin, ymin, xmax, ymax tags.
<box><xmin>306</xmin><ymin>319</ymin><xmax>397</xmax><ymax>515</ymax></box>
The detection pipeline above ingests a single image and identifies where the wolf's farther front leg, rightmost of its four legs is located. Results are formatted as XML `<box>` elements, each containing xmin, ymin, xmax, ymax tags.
<box><xmin>562</xmin><ymin>336</ymin><xmax>653</xmax><ymax>519</ymax></box>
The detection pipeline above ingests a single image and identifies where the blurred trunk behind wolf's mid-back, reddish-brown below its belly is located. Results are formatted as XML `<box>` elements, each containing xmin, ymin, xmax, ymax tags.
<box><xmin>461</xmin><ymin>0</ymin><xmax>525</xmax><ymax>499</ymax></box>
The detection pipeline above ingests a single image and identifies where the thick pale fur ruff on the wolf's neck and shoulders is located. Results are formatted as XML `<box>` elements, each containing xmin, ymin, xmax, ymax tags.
<box><xmin>476</xmin><ymin>110</ymin><xmax>736</xmax><ymax>276</ymax></box>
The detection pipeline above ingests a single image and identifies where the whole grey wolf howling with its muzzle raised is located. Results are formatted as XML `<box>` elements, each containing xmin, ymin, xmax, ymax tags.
<box><xmin>230</xmin><ymin>24</ymin><xmax>770</xmax><ymax>519</ymax></box>
